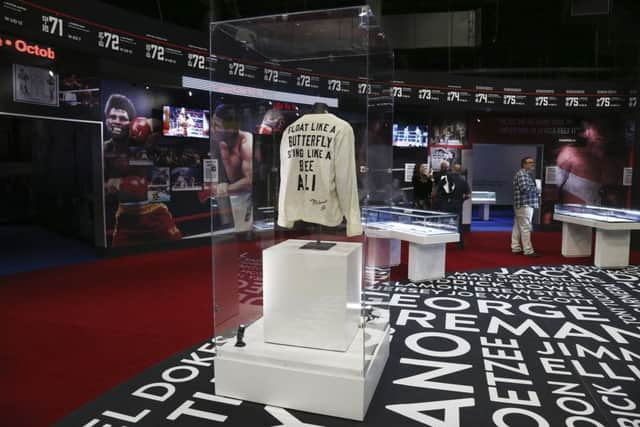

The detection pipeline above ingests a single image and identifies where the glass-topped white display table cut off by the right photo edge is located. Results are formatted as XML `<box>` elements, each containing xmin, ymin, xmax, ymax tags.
<box><xmin>553</xmin><ymin>204</ymin><xmax>640</xmax><ymax>268</ymax></box>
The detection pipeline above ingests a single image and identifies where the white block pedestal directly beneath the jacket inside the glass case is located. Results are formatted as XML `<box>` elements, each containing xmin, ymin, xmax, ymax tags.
<box><xmin>262</xmin><ymin>240</ymin><xmax>362</xmax><ymax>351</ymax></box>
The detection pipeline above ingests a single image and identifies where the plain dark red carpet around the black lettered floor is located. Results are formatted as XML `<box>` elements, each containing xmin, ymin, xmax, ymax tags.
<box><xmin>0</xmin><ymin>232</ymin><xmax>640</xmax><ymax>427</ymax></box>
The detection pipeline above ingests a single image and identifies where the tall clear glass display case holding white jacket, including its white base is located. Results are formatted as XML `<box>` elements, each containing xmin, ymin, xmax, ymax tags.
<box><xmin>208</xmin><ymin>7</ymin><xmax>393</xmax><ymax>420</ymax></box>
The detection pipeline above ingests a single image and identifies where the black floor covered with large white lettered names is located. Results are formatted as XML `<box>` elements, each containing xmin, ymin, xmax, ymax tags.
<box><xmin>56</xmin><ymin>266</ymin><xmax>640</xmax><ymax>427</ymax></box>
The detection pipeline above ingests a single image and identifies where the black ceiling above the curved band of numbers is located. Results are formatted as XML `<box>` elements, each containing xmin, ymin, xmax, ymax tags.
<box><xmin>104</xmin><ymin>0</ymin><xmax>640</xmax><ymax>80</ymax></box>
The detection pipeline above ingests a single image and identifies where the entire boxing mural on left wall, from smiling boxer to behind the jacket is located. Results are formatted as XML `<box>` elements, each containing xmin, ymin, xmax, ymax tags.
<box><xmin>101</xmin><ymin>81</ymin><xmax>299</xmax><ymax>247</ymax></box>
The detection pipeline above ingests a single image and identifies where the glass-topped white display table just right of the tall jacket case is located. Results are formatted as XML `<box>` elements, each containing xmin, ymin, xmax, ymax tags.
<box><xmin>362</xmin><ymin>206</ymin><xmax>460</xmax><ymax>282</ymax></box>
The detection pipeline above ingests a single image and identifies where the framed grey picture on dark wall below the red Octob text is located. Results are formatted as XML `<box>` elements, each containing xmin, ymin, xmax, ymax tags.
<box><xmin>13</xmin><ymin>64</ymin><xmax>60</xmax><ymax>107</ymax></box>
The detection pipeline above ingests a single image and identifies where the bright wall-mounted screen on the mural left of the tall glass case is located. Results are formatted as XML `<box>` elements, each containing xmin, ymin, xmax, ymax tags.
<box><xmin>162</xmin><ymin>105</ymin><xmax>209</xmax><ymax>139</ymax></box>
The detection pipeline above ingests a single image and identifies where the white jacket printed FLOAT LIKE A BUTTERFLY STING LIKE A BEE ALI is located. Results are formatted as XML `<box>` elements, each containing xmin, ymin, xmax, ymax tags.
<box><xmin>278</xmin><ymin>113</ymin><xmax>362</xmax><ymax>236</ymax></box>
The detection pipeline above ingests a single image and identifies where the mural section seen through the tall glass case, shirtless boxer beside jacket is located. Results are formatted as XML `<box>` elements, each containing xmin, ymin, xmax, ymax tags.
<box><xmin>208</xmin><ymin>100</ymin><xmax>299</xmax><ymax>232</ymax></box>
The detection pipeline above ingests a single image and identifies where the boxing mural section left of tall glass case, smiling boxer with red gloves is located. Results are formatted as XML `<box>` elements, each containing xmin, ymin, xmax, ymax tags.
<box><xmin>102</xmin><ymin>82</ymin><xmax>209</xmax><ymax>247</ymax></box>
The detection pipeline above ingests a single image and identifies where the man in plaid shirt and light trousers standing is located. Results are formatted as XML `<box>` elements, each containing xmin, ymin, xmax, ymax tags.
<box><xmin>511</xmin><ymin>157</ymin><xmax>540</xmax><ymax>257</ymax></box>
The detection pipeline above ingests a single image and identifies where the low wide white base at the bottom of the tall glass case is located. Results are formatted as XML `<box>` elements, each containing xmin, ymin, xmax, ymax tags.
<box><xmin>214</xmin><ymin>320</ymin><xmax>389</xmax><ymax>421</ymax></box>
